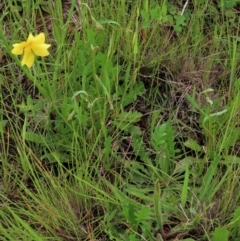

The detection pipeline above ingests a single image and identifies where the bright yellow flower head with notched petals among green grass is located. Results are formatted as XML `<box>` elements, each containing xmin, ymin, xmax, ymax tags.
<box><xmin>12</xmin><ymin>33</ymin><xmax>51</xmax><ymax>68</ymax></box>
